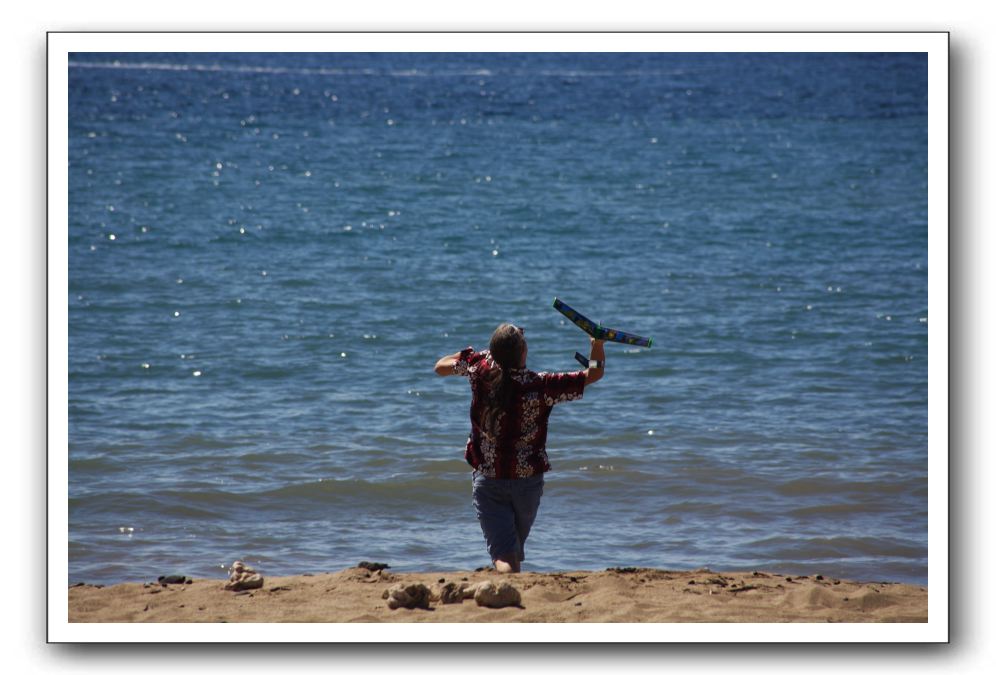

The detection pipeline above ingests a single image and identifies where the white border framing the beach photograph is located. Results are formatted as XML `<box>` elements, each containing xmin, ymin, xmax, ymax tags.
<box><xmin>48</xmin><ymin>31</ymin><xmax>949</xmax><ymax>643</ymax></box>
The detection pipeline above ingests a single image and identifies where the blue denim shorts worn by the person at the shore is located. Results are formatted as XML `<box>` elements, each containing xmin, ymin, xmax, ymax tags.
<box><xmin>474</xmin><ymin>471</ymin><xmax>543</xmax><ymax>561</ymax></box>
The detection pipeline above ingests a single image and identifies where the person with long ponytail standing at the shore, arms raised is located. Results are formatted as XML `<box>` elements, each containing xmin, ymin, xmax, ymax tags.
<box><xmin>436</xmin><ymin>323</ymin><xmax>605</xmax><ymax>572</ymax></box>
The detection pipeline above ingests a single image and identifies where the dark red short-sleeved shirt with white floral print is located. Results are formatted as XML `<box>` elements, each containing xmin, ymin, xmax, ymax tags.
<box><xmin>454</xmin><ymin>347</ymin><xmax>585</xmax><ymax>478</ymax></box>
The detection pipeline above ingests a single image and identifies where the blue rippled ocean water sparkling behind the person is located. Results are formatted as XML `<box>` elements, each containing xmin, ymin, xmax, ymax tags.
<box><xmin>67</xmin><ymin>53</ymin><xmax>928</xmax><ymax>583</ymax></box>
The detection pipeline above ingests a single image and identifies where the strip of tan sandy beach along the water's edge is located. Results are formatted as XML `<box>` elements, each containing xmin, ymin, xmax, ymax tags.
<box><xmin>69</xmin><ymin>567</ymin><xmax>928</xmax><ymax>623</ymax></box>
